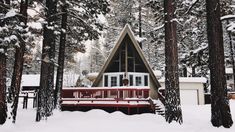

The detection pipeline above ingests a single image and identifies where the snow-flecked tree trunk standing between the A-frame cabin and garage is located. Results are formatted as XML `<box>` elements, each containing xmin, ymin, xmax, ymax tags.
<box><xmin>164</xmin><ymin>0</ymin><xmax>183</xmax><ymax>124</ymax></box>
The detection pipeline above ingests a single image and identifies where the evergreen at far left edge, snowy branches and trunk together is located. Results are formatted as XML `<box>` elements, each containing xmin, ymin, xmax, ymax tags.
<box><xmin>0</xmin><ymin>0</ymin><xmax>15</xmax><ymax>124</ymax></box>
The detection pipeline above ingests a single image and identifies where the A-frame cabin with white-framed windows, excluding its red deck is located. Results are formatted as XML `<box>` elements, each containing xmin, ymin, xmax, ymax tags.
<box><xmin>93</xmin><ymin>24</ymin><xmax>160</xmax><ymax>98</ymax></box>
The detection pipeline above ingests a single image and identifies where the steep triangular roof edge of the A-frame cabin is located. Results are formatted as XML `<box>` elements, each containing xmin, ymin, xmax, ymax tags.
<box><xmin>93</xmin><ymin>24</ymin><xmax>160</xmax><ymax>88</ymax></box>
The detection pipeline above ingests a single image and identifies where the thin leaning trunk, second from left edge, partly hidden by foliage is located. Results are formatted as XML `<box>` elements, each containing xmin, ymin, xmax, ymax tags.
<box><xmin>11</xmin><ymin>0</ymin><xmax>28</xmax><ymax>123</ymax></box>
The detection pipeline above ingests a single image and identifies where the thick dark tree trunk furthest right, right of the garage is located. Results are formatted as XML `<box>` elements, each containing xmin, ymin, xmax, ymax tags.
<box><xmin>206</xmin><ymin>0</ymin><xmax>233</xmax><ymax>128</ymax></box>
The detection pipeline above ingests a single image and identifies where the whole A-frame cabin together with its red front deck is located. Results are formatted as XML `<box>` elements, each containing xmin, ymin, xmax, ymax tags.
<box><xmin>61</xmin><ymin>24</ymin><xmax>160</xmax><ymax>114</ymax></box>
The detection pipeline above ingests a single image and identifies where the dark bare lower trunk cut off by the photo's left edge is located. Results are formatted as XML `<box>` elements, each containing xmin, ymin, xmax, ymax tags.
<box><xmin>0</xmin><ymin>46</ymin><xmax>7</xmax><ymax>124</ymax></box>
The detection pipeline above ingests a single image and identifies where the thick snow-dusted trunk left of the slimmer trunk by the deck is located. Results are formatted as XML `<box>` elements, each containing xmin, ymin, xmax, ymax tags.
<box><xmin>36</xmin><ymin>0</ymin><xmax>57</xmax><ymax>121</ymax></box>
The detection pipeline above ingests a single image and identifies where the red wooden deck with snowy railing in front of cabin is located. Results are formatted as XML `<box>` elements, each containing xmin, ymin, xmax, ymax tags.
<box><xmin>61</xmin><ymin>87</ymin><xmax>155</xmax><ymax>114</ymax></box>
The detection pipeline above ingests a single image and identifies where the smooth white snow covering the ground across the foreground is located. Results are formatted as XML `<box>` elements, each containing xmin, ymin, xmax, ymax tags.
<box><xmin>0</xmin><ymin>100</ymin><xmax>235</xmax><ymax>132</ymax></box>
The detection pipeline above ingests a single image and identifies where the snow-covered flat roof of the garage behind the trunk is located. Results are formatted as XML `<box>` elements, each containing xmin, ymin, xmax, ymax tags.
<box><xmin>158</xmin><ymin>77</ymin><xmax>207</xmax><ymax>83</ymax></box>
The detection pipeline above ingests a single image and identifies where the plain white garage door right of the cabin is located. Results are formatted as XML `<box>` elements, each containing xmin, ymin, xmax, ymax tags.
<box><xmin>180</xmin><ymin>89</ymin><xmax>198</xmax><ymax>105</ymax></box>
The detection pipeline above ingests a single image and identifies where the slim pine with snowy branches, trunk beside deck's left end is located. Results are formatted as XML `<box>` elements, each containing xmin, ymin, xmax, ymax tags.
<box><xmin>54</xmin><ymin>0</ymin><xmax>109</xmax><ymax>108</ymax></box>
